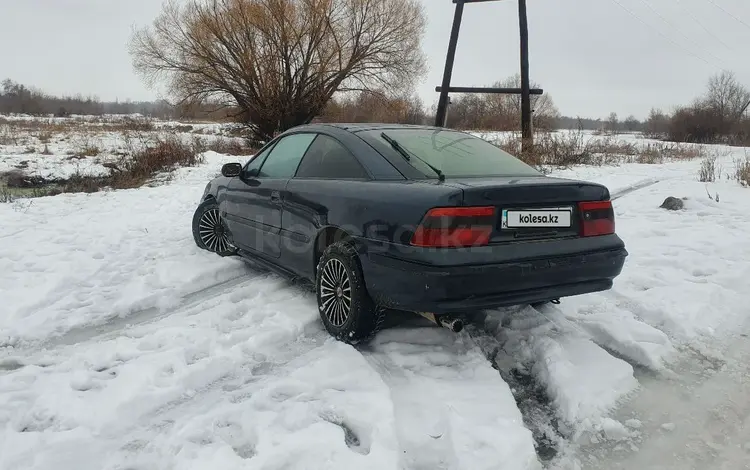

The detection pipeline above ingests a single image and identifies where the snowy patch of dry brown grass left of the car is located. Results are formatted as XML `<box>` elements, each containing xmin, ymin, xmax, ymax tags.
<box><xmin>0</xmin><ymin>116</ymin><xmax>256</xmax><ymax>201</ymax></box>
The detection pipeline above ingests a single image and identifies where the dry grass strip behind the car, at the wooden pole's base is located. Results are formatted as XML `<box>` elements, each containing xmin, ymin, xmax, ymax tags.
<box><xmin>494</xmin><ymin>131</ymin><xmax>706</xmax><ymax>171</ymax></box>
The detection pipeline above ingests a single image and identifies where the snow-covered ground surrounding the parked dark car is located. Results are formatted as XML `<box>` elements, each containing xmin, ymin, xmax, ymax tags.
<box><xmin>0</xmin><ymin>125</ymin><xmax>750</xmax><ymax>470</ymax></box>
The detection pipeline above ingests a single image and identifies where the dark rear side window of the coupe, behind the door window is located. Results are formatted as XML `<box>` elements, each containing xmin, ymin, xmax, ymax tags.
<box><xmin>295</xmin><ymin>134</ymin><xmax>369</xmax><ymax>179</ymax></box>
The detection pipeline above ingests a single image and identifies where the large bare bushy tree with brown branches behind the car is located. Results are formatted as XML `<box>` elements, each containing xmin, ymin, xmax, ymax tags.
<box><xmin>130</xmin><ymin>0</ymin><xmax>426</xmax><ymax>140</ymax></box>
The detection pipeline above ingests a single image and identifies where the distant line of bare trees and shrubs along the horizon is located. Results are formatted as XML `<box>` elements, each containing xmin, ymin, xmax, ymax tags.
<box><xmin>16</xmin><ymin>72</ymin><xmax>750</xmax><ymax>145</ymax></box>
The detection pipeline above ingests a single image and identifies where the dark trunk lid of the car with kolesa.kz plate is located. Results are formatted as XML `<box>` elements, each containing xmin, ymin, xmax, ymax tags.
<box><xmin>445</xmin><ymin>176</ymin><xmax>610</xmax><ymax>244</ymax></box>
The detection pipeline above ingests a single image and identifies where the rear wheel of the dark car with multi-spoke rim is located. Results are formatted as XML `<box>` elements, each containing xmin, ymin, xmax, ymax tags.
<box><xmin>315</xmin><ymin>242</ymin><xmax>385</xmax><ymax>344</ymax></box>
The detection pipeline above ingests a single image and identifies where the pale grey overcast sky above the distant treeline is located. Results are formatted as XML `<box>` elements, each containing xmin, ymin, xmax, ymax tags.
<box><xmin>0</xmin><ymin>0</ymin><xmax>750</xmax><ymax>118</ymax></box>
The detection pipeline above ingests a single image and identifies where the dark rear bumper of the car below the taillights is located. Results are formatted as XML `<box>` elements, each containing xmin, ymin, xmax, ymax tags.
<box><xmin>360</xmin><ymin>239</ymin><xmax>628</xmax><ymax>313</ymax></box>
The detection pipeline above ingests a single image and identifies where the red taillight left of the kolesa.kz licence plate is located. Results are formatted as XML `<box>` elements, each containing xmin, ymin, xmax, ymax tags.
<box><xmin>411</xmin><ymin>206</ymin><xmax>495</xmax><ymax>248</ymax></box>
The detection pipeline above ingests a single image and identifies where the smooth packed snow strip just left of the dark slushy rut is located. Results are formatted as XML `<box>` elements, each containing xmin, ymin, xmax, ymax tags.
<box><xmin>358</xmin><ymin>320</ymin><xmax>541</xmax><ymax>470</ymax></box>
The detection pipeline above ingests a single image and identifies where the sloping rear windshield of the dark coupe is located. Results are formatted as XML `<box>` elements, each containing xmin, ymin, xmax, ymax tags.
<box><xmin>361</xmin><ymin>128</ymin><xmax>542</xmax><ymax>178</ymax></box>
